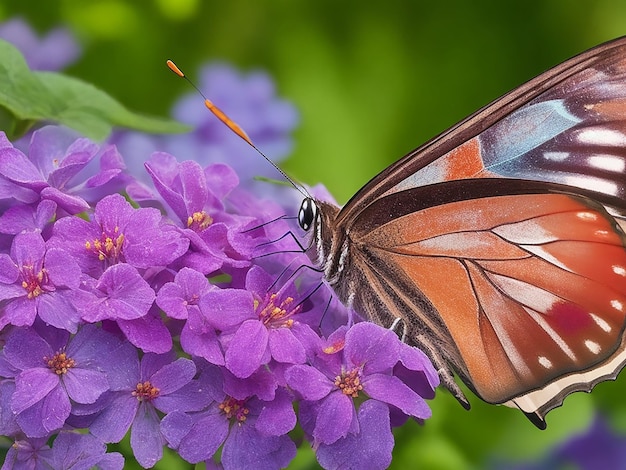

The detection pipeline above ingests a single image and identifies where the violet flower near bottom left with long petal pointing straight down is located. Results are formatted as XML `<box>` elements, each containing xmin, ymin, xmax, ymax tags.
<box><xmin>90</xmin><ymin>353</ymin><xmax>200</xmax><ymax>467</ymax></box>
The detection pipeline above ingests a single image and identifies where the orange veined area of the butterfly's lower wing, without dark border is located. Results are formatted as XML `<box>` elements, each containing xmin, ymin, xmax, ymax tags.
<box><xmin>368</xmin><ymin>194</ymin><xmax>626</xmax><ymax>403</ymax></box>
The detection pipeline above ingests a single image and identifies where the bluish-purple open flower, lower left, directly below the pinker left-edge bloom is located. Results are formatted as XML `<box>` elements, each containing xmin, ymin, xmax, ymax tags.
<box><xmin>4</xmin><ymin>325</ymin><xmax>115</xmax><ymax>437</ymax></box>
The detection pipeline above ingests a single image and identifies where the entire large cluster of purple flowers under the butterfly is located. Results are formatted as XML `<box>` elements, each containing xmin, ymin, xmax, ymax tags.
<box><xmin>0</xmin><ymin>123</ymin><xmax>438</xmax><ymax>469</ymax></box>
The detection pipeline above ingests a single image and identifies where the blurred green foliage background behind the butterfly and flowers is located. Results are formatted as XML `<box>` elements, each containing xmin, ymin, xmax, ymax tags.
<box><xmin>0</xmin><ymin>0</ymin><xmax>626</xmax><ymax>469</ymax></box>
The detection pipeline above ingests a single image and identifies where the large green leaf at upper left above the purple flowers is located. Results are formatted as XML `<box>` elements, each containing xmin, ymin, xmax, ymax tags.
<box><xmin>0</xmin><ymin>40</ymin><xmax>189</xmax><ymax>140</ymax></box>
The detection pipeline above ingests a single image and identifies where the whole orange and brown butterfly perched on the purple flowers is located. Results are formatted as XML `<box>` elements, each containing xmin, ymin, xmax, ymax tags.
<box><xmin>298</xmin><ymin>37</ymin><xmax>626</xmax><ymax>429</ymax></box>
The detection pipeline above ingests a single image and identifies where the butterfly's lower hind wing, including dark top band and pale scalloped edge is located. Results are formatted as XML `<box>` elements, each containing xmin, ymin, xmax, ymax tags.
<box><xmin>336</xmin><ymin>179</ymin><xmax>626</xmax><ymax>427</ymax></box>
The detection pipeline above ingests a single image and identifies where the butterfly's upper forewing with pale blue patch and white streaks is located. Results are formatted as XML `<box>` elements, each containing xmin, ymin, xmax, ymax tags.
<box><xmin>337</xmin><ymin>37</ymin><xmax>626</xmax><ymax>225</ymax></box>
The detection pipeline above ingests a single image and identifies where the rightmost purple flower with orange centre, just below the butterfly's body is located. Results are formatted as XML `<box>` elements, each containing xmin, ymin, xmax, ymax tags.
<box><xmin>285</xmin><ymin>322</ymin><xmax>436</xmax><ymax>448</ymax></box>
